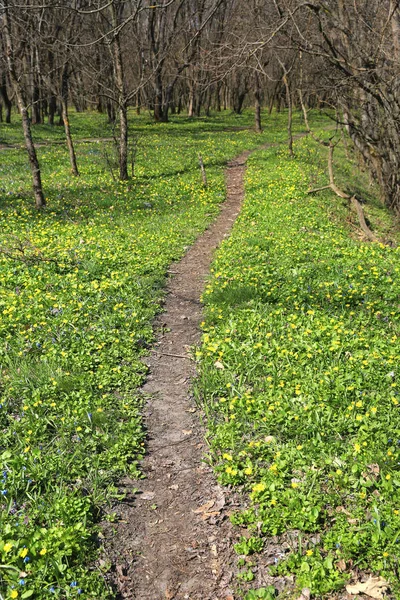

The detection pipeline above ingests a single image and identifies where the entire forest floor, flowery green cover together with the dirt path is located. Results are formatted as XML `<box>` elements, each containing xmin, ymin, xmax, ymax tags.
<box><xmin>0</xmin><ymin>113</ymin><xmax>400</xmax><ymax>600</ymax></box>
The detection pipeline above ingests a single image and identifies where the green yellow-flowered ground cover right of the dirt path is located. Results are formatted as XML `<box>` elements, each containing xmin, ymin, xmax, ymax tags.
<box><xmin>196</xmin><ymin>139</ymin><xmax>400</xmax><ymax>598</ymax></box>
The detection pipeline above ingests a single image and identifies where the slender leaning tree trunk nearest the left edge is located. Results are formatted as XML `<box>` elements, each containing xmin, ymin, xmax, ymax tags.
<box><xmin>3</xmin><ymin>0</ymin><xmax>46</xmax><ymax>208</ymax></box>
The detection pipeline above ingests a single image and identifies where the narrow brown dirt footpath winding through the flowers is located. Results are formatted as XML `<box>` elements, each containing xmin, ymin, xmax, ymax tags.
<box><xmin>104</xmin><ymin>152</ymin><xmax>255</xmax><ymax>600</ymax></box>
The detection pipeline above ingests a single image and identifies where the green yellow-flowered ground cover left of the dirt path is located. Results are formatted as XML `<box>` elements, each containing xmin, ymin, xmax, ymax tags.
<box><xmin>0</xmin><ymin>114</ymin><xmax>301</xmax><ymax>600</ymax></box>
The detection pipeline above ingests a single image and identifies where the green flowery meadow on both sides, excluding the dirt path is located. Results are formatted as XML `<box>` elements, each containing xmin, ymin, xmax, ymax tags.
<box><xmin>0</xmin><ymin>112</ymin><xmax>400</xmax><ymax>600</ymax></box>
